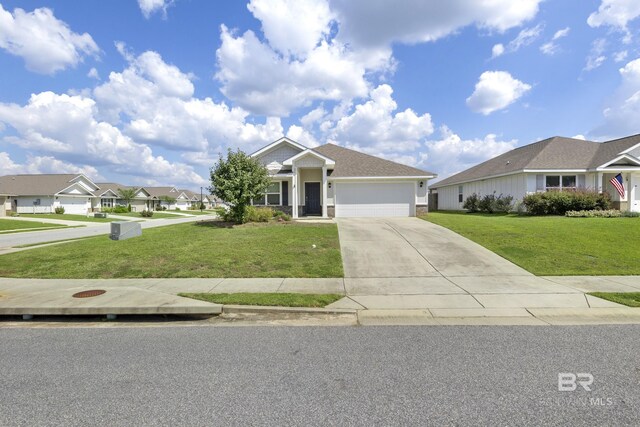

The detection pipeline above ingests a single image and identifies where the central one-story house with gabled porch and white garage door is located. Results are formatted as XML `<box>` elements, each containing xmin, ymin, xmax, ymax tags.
<box><xmin>251</xmin><ymin>138</ymin><xmax>436</xmax><ymax>218</ymax></box>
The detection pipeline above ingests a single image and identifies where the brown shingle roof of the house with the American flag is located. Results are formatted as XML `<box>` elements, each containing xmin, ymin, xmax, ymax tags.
<box><xmin>431</xmin><ymin>135</ymin><xmax>640</xmax><ymax>188</ymax></box>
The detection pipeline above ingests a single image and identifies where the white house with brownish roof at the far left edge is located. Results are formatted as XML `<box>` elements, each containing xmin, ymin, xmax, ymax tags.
<box><xmin>0</xmin><ymin>174</ymin><xmax>98</xmax><ymax>215</ymax></box>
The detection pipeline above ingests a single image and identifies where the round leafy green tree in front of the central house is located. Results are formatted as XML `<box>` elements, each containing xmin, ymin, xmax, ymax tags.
<box><xmin>209</xmin><ymin>149</ymin><xmax>271</xmax><ymax>223</ymax></box>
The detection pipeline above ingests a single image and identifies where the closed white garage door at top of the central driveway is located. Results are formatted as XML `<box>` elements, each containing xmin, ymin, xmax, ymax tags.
<box><xmin>334</xmin><ymin>182</ymin><xmax>416</xmax><ymax>218</ymax></box>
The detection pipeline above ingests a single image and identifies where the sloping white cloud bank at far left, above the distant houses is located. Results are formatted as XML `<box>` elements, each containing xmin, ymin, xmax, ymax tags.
<box><xmin>0</xmin><ymin>92</ymin><xmax>206</xmax><ymax>185</ymax></box>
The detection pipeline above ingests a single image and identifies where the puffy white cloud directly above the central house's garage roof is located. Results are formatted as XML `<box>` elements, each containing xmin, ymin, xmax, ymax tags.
<box><xmin>324</xmin><ymin>84</ymin><xmax>433</xmax><ymax>158</ymax></box>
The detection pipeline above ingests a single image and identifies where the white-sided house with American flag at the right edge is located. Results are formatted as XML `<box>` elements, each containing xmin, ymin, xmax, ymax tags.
<box><xmin>431</xmin><ymin>135</ymin><xmax>640</xmax><ymax>212</ymax></box>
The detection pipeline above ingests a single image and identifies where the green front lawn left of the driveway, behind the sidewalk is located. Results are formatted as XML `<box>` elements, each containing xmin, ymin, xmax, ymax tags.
<box><xmin>0</xmin><ymin>221</ymin><xmax>343</xmax><ymax>279</ymax></box>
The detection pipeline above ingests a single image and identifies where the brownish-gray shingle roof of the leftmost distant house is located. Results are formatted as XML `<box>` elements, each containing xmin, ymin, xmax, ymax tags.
<box><xmin>0</xmin><ymin>174</ymin><xmax>94</xmax><ymax>196</ymax></box>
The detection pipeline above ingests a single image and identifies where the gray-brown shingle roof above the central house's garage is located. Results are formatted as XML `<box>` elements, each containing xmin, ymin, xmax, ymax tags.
<box><xmin>313</xmin><ymin>144</ymin><xmax>436</xmax><ymax>178</ymax></box>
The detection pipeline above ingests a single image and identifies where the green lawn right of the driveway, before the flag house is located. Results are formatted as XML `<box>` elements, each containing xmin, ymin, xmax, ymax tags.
<box><xmin>422</xmin><ymin>212</ymin><xmax>640</xmax><ymax>276</ymax></box>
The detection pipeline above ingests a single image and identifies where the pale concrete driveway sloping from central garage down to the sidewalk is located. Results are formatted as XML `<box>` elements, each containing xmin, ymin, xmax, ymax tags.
<box><xmin>336</xmin><ymin>218</ymin><xmax>531</xmax><ymax>278</ymax></box>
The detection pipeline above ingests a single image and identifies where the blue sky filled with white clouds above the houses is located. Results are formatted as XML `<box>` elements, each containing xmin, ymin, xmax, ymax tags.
<box><xmin>0</xmin><ymin>0</ymin><xmax>640</xmax><ymax>188</ymax></box>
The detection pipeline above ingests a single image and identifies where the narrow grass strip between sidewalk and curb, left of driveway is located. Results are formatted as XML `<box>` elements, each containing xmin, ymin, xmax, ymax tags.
<box><xmin>178</xmin><ymin>293</ymin><xmax>344</xmax><ymax>307</ymax></box>
